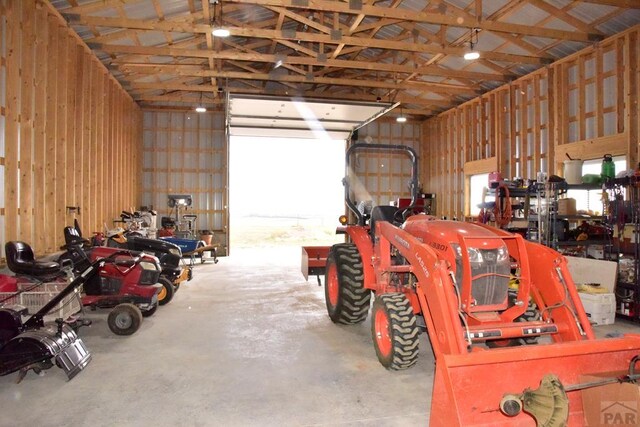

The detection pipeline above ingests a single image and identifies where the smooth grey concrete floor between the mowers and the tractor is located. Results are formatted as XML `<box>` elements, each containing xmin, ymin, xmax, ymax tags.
<box><xmin>0</xmin><ymin>247</ymin><xmax>640</xmax><ymax>426</ymax></box>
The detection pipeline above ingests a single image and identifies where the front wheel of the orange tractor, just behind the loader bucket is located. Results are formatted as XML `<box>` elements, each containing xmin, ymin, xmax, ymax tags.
<box><xmin>371</xmin><ymin>293</ymin><xmax>420</xmax><ymax>371</ymax></box>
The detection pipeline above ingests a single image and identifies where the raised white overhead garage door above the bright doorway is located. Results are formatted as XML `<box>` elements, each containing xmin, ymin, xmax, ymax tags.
<box><xmin>227</xmin><ymin>94</ymin><xmax>397</xmax><ymax>140</ymax></box>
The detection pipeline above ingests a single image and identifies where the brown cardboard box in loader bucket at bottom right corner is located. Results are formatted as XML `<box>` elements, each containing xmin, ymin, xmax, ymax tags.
<box><xmin>580</xmin><ymin>372</ymin><xmax>640</xmax><ymax>427</ymax></box>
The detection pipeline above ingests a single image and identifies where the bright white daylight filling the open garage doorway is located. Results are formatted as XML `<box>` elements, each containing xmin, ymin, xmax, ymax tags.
<box><xmin>229</xmin><ymin>136</ymin><xmax>345</xmax><ymax>248</ymax></box>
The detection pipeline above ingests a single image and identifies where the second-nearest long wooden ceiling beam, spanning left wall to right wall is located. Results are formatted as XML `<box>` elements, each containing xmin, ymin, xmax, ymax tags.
<box><xmin>77</xmin><ymin>16</ymin><xmax>550</xmax><ymax>65</ymax></box>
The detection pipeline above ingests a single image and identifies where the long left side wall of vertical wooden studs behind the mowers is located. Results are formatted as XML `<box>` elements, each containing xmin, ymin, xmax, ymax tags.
<box><xmin>0</xmin><ymin>0</ymin><xmax>142</xmax><ymax>255</ymax></box>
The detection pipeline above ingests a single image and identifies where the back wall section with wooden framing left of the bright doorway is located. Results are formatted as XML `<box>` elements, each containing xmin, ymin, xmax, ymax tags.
<box><xmin>140</xmin><ymin>111</ymin><xmax>228</xmax><ymax>255</ymax></box>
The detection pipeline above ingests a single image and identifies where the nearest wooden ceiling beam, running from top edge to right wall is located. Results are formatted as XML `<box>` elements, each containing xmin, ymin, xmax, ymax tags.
<box><xmin>225</xmin><ymin>0</ymin><xmax>602</xmax><ymax>42</ymax></box>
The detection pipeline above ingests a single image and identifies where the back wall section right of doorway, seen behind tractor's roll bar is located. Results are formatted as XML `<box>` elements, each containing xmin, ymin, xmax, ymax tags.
<box><xmin>351</xmin><ymin>119</ymin><xmax>421</xmax><ymax>212</ymax></box>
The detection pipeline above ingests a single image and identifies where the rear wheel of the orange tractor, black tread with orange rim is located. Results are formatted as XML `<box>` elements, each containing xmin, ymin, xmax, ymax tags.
<box><xmin>324</xmin><ymin>243</ymin><xmax>371</xmax><ymax>325</ymax></box>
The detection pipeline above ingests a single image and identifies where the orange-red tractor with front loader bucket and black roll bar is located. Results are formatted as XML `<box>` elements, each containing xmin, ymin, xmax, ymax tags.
<box><xmin>308</xmin><ymin>143</ymin><xmax>640</xmax><ymax>426</ymax></box>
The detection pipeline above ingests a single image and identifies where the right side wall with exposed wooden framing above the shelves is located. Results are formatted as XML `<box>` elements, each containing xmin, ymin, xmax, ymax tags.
<box><xmin>422</xmin><ymin>25</ymin><xmax>640</xmax><ymax>218</ymax></box>
